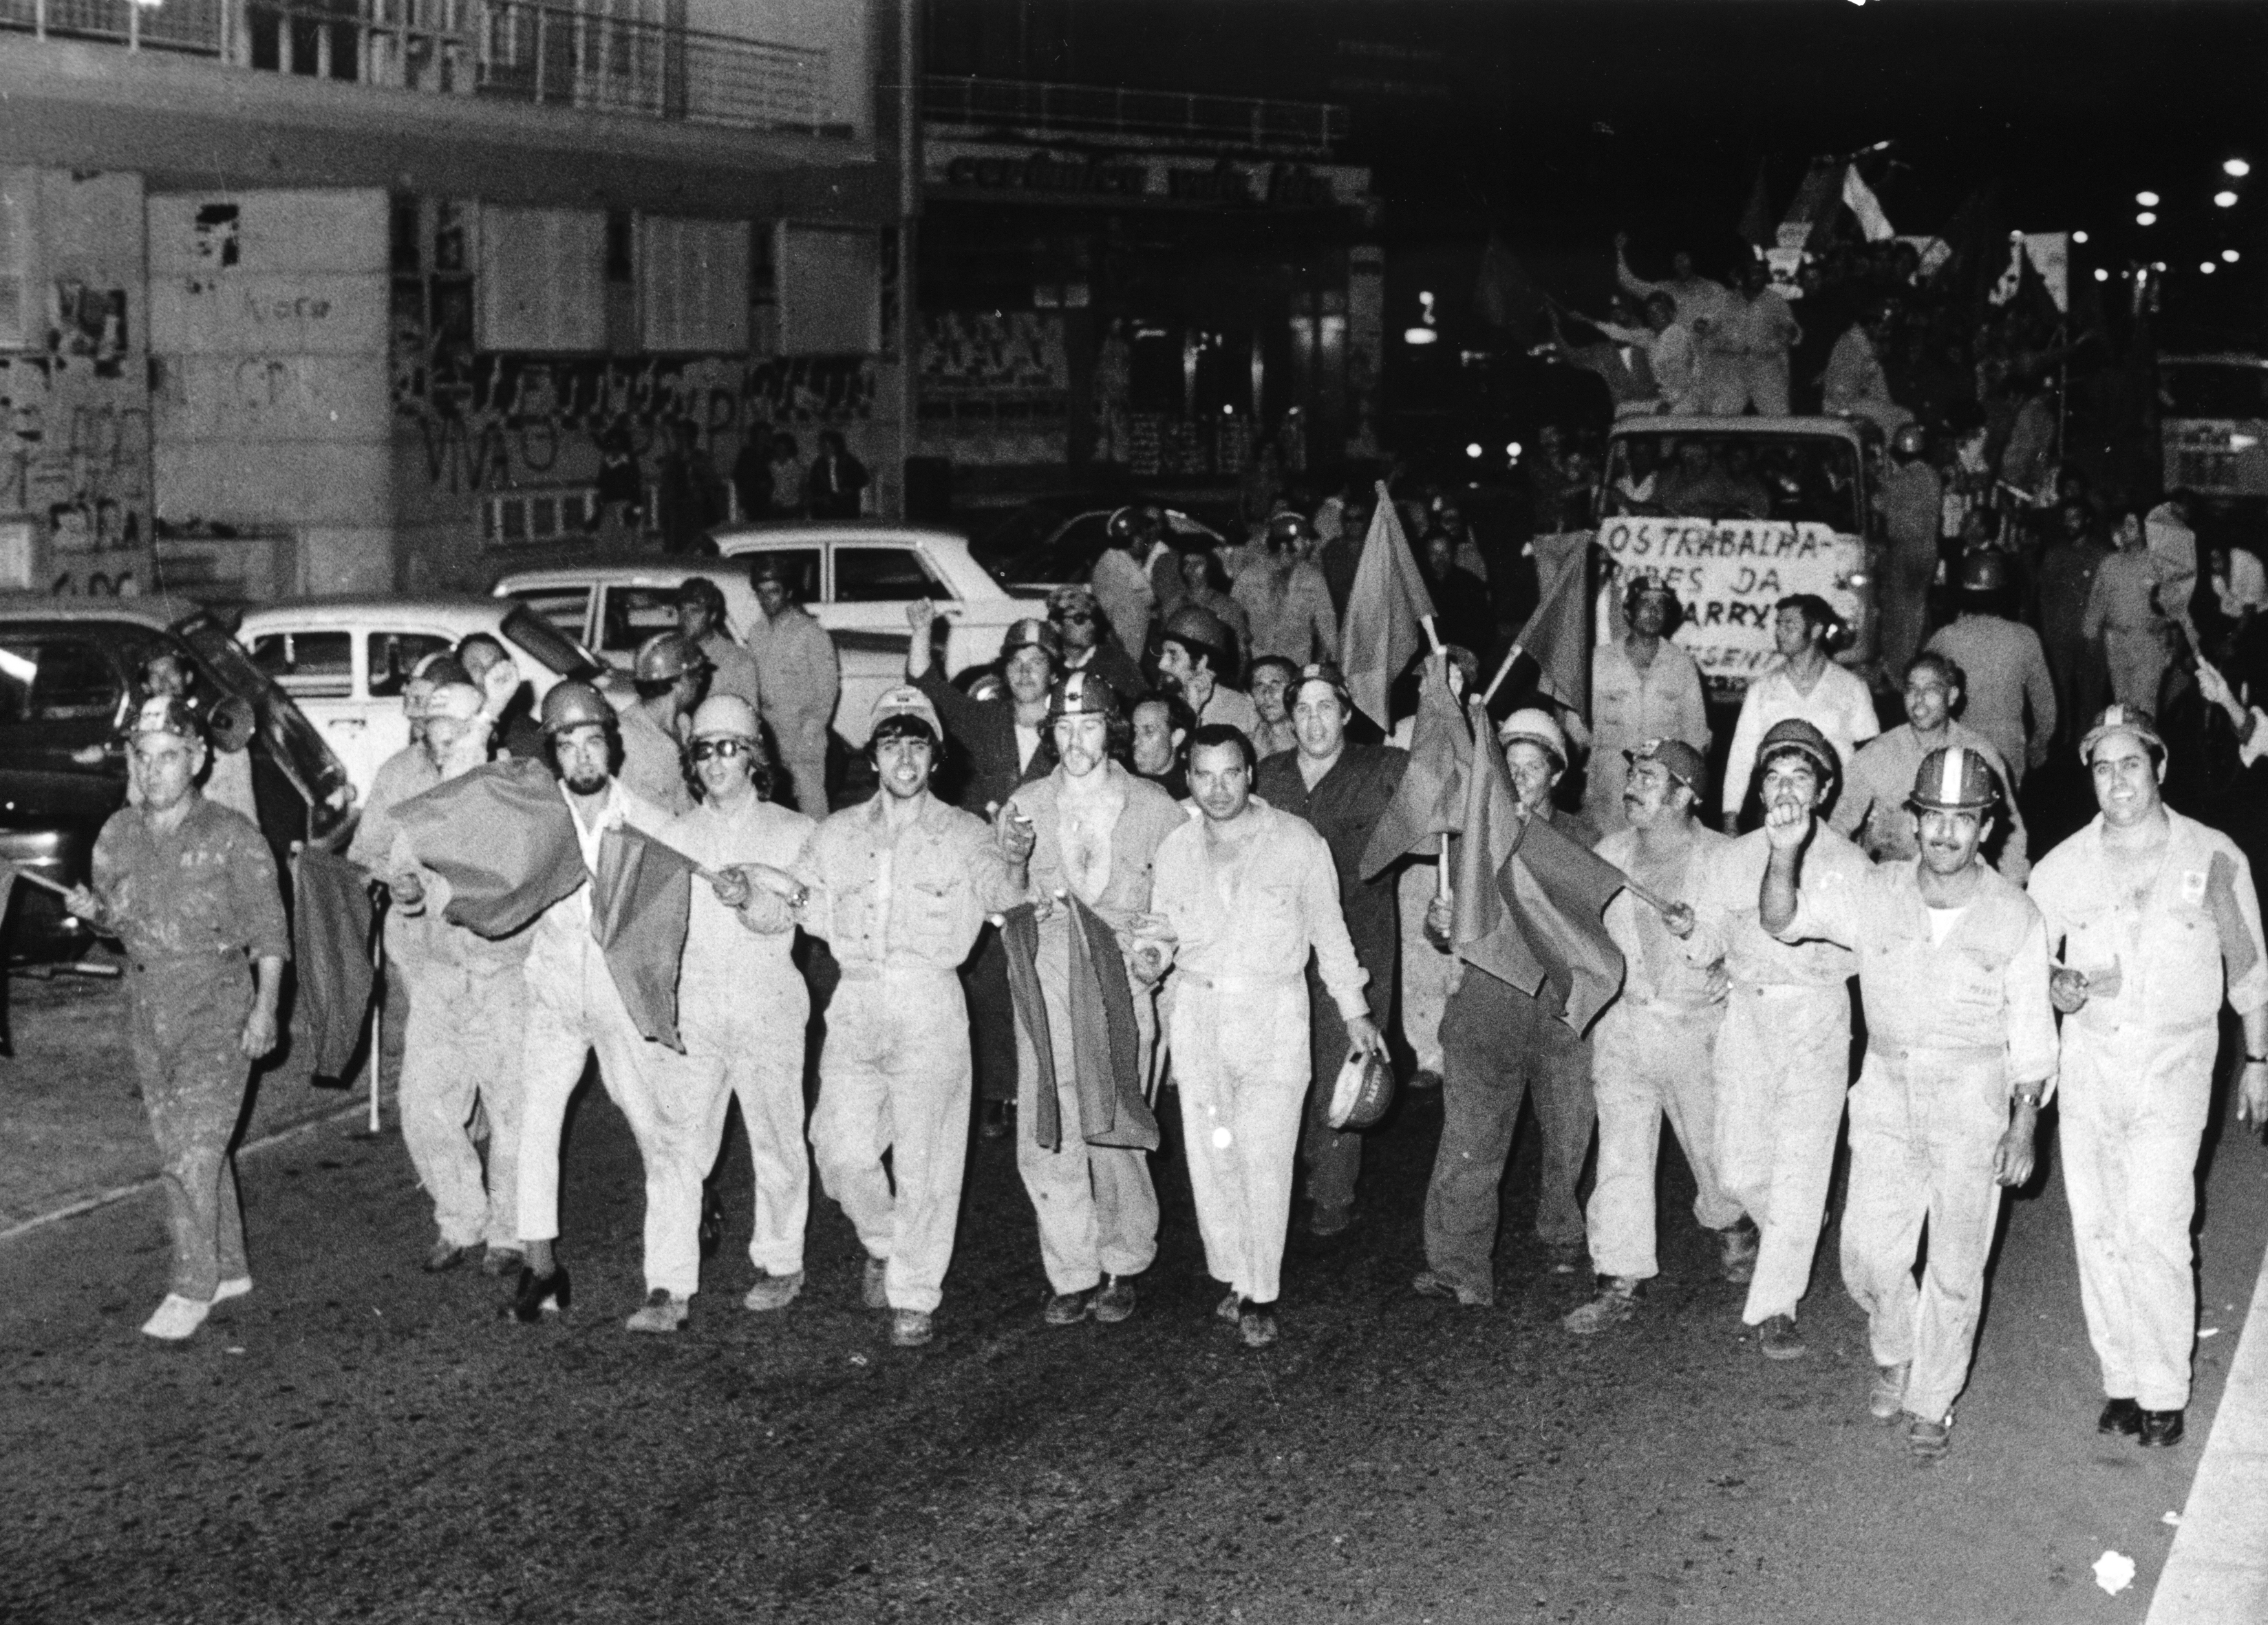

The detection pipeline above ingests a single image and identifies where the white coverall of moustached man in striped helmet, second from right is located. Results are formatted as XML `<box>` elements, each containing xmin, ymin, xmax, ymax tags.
<box><xmin>1780</xmin><ymin>854</ymin><xmax>2055</xmax><ymax>1421</ymax></box>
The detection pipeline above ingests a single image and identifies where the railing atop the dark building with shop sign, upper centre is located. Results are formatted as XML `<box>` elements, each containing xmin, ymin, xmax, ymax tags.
<box><xmin>921</xmin><ymin>75</ymin><xmax>1347</xmax><ymax>156</ymax></box>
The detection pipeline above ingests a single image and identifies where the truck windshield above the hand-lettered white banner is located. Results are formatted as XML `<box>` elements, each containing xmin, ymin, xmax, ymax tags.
<box><xmin>1601</xmin><ymin>431</ymin><xmax>1864</xmax><ymax>535</ymax></box>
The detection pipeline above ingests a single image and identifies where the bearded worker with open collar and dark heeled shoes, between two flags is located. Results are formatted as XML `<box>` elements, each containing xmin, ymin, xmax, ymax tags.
<box><xmin>511</xmin><ymin>680</ymin><xmax>700</xmax><ymax>1331</ymax></box>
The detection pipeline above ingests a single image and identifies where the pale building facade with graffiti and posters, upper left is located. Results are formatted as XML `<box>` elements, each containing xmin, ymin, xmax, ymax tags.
<box><xmin>0</xmin><ymin>0</ymin><xmax>910</xmax><ymax>601</ymax></box>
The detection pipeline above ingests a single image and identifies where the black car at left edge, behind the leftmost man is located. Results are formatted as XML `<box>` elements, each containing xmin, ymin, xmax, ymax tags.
<box><xmin>0</xmin><ymin>594</ymin><xmax>354</xmax><ymax>961</ymax></box>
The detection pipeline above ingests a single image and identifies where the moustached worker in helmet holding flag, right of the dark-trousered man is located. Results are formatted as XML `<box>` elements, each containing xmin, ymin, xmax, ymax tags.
<box><xmin>1563</xmin><ymin>739</ymin><xmax>1740</xmax><ymax>1335</ymax></box>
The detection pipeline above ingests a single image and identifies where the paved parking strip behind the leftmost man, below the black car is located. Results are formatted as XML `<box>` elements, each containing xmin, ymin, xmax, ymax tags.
<box><xmin>0</xmin><ymin>977</ymin><xmax>367</xmax><ymax>1233</ymax></box>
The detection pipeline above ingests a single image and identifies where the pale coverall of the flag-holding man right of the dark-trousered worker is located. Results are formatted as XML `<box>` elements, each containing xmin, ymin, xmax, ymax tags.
<box><xmin>1583</xmin><ymin>825</ymin><xmax>1740</xmax><ymax>1280</ymax></box>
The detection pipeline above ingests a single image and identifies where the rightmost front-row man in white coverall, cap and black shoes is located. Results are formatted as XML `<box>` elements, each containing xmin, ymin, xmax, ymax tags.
<box><xmin>2030</xmin><ymin>705</ymin><xmax>2268</xmax><ymax>1446</ymax></box>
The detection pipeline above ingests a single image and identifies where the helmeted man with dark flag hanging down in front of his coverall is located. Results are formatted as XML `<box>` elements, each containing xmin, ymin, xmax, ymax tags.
<box><xmin>1009</xmin><ymin>671</ymin><xmax>1186</xmax><ymax>1326</ymax></box>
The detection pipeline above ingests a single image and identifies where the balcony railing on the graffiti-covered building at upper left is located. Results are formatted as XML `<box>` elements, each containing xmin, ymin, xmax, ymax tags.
<box><xmin>0</xmin><ymin>0</ymin><xmax>830</xmax><ymax>131</ymax></box>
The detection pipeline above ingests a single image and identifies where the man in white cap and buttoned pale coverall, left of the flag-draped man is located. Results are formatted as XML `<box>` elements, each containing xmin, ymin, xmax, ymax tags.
<box><xmin>794</xmin><ymin>685</ymin><xmax>1032</xmax><ymax>1348</ymax></box>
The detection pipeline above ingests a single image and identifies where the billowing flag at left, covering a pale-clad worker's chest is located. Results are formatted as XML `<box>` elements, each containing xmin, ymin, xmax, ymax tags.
<box><xmin>395</xmin><ymin>760</ymin><xmax>590</xmax><ymax>936</ymax></box>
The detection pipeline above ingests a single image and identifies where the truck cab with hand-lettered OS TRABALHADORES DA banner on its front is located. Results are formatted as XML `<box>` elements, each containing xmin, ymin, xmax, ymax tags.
<box><xmin>1596</xmin><ymin>417</ymin><xmax>1883</xmax><ymax>702</ymax></box>
